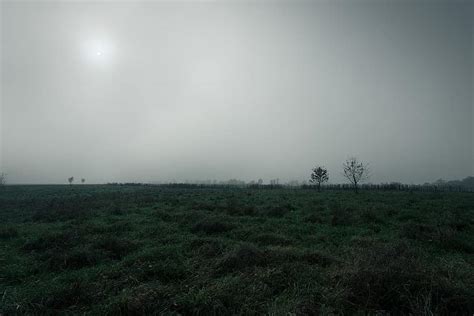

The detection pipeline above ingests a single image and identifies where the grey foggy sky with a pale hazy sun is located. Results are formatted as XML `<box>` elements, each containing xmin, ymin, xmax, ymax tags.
<box><xmin>0</xmin><ymin>0</ymin><xmax>474</xmax><ymax>183</ymax></box>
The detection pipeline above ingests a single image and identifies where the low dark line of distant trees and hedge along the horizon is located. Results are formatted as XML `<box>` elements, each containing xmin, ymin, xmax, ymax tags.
<box><xmin>107</xmin><ymin>177</ymin><xmax>474</xmax><ymax>192</ymax></box>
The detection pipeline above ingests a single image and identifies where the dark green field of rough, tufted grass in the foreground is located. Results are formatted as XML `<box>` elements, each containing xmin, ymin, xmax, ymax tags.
<box><xmin>0</xmin><ymin>185</ymin><xmax>474</xmax><ymax>315</ymax></box>
